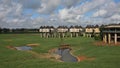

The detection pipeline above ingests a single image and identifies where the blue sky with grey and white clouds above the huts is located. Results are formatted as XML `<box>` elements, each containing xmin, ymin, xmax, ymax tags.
<box><xmin>0</xmin><ymin>0</ymin><xmax>120</xmax><ymax>28</ymax></box>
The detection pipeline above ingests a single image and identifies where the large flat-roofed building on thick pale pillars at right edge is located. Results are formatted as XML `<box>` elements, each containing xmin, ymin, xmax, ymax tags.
<box><xmin>102</xmin><ymin>24</ymin><xmax>120</xmax><ymax>44</ymax></box>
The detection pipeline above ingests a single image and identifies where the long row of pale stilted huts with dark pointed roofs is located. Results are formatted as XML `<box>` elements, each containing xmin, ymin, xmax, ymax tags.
<box><xmin>39</xmin><ymin>25</ymin><xmax>100</xmax><ymax>38</ymax></box>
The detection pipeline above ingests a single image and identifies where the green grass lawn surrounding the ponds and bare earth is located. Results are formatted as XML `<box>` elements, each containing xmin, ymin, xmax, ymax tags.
<box><xmin>0</xmin><ymin>34</ymin><xmax>120</xmax><ymax>68</ymax></box>
